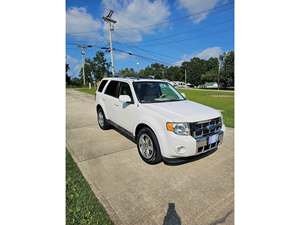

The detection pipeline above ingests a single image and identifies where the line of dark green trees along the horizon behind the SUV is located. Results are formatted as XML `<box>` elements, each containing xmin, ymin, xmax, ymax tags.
<box><xmin>66</xmin><ymin>51</ymin><xmax>234</xmax><ymax>88</ymax></box>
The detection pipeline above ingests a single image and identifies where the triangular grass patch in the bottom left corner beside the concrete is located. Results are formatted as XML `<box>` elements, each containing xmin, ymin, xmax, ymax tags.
<box><xmin>66</xmin><ymin>151</ymin><xmax>113</xmax><ymax>225</ymax></box>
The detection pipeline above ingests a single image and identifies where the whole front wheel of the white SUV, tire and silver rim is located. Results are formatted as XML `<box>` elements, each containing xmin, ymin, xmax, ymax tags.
<box><xmin>137</xmin><ymin>127</ymin><xmax>162</xmax><ymax>164</ymax></box>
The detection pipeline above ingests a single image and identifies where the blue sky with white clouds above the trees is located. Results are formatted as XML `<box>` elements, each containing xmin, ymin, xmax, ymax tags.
<box><xmin>66</xmin><ymin>0</ymin><xmax>234</xmax><ymax>77</ymax></box>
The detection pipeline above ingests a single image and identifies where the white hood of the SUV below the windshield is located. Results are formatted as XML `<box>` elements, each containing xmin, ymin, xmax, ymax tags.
<box><xmin>142</xmin><ymin>100</ymin><xmax>221</xmax><ymax>122</ymax></box>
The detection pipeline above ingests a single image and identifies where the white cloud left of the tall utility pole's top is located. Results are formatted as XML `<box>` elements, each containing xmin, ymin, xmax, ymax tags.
<box><xmin>66</xmin><ymin>7</ymin><xmax>101</xmax><ymax>41</ymax></box>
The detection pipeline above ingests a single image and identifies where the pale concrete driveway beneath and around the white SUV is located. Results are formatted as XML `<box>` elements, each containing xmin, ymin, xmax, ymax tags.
<box><xmin>66</xmin><ymin>89</ymin><xmax>234</xmax><ymax>225</ymax></box>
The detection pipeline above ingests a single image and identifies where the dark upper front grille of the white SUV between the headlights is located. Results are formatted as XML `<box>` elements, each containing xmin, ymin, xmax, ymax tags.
<box><xmin>190</xmin><ymin>117</ymin><xmax>222</xmax><ymax>138</ymax></box>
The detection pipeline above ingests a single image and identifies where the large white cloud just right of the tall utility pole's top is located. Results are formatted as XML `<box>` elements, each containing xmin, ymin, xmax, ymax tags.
<box><xmin>102</xmin><ymin>0</ymin><xmax>170</xmax><ymax>42</ymax></box>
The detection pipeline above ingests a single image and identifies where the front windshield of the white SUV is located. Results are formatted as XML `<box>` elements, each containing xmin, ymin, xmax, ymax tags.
<box><xmin>133</xmin><ymin>81</ymin><xmax>185</xmax><ymax>103</ymax></box>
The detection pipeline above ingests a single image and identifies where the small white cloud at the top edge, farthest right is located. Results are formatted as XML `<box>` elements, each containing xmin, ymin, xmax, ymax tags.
<box><xmin>178</xmin><ymin>0</ymin><xmax>218</xmax><ymax>23</ymax></box>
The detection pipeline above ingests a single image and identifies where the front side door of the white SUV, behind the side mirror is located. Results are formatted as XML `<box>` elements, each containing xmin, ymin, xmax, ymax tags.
<box><xmin>115</xmin><ymin>82</ymin><xmax>137</xmax><ymax>133</ymax></box>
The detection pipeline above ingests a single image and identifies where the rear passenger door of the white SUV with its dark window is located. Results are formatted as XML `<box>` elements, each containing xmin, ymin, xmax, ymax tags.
<box><xmin>103</xmin><ymin>80</ymin><xmax>120</xmax><ymax>123</ymax></box>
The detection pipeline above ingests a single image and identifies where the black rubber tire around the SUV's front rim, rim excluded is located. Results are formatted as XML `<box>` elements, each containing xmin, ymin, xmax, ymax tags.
<box><xmin>136</xmin><ymin>127</ymin><xmax>162</xmax><ymax>164</ymax></box>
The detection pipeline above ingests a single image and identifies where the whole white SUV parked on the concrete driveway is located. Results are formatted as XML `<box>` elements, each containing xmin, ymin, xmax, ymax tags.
<box><xmin>96</xmin><ymin>78</ymin><xmax>225</xmax><ymax>164</ymax></box>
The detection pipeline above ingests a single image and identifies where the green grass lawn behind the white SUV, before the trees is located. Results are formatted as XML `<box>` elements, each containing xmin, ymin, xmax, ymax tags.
<box><xmin>77</xmin><ymin>88</ymin><xmax>234</xmax><ymax>127</ymax></box>
